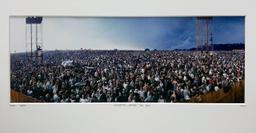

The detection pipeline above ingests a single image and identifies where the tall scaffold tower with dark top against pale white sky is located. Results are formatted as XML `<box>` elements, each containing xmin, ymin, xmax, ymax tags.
<box><xmin>25</xmin><ymin>16</ymin><xmax>43</xmax><ymax>62</ymax></box>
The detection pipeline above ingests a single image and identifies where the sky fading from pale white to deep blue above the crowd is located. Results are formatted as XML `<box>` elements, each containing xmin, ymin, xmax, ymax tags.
<box><xmin>10</xmin><ymin>16</ymin><xmax>245</xmax><ymax>52</ymax></box>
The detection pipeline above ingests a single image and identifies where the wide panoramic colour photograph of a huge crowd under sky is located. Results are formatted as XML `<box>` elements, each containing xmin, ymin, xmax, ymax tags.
<box><xmin>9</xmin><ymin>16</ymin><xmax>245</xmax><ymax>104</ymax></box>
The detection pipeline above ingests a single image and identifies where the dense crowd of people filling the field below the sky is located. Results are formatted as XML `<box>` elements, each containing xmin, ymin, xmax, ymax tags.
<box><xmin>11</xmin><ymin>50</ymin><xmax>245</xmax><ymax>102</ymax></box>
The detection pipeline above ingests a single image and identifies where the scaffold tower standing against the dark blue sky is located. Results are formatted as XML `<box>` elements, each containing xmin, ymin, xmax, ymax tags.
<box><xmin>196</xmin><ymin>17</ymin><xmax>213</xmax><ymax>51</ymax></box>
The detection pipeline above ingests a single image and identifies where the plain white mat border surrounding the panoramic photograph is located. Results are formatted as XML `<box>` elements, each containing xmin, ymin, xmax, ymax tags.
<box><xmin>0</xmin><ymin>0</ymin><xmax>256</xmax><ymax>133</ymax></box>
